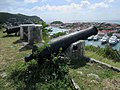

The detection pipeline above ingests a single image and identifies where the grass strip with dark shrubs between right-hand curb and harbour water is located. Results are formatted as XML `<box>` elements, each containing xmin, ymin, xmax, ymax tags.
<box><xmin>85</xmin><ymin>46</ymin><xmax>120</xmax><ymax>68</ymax></box>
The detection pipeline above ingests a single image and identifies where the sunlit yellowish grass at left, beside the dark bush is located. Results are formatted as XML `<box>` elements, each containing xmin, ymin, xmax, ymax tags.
<box><xmin>0</xmin><ymin>31</ymin><xmax>31</xmax><ymax>90</ymax></box>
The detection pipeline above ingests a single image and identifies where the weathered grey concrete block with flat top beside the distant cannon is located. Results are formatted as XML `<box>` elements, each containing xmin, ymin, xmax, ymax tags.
<box><xmin>20</xmin><ymin>24</ymin><xmax>42</xmax><ymax>44</ymax></box>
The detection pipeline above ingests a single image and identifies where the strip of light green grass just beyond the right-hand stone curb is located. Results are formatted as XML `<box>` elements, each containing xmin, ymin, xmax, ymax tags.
<box><xmin>85</xmin><ymin>50</ymin><xmax>120</xmax><ymax>68</ymax></box>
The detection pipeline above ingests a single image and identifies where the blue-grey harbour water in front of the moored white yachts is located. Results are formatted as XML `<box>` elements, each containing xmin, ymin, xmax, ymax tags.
<box><xmin>85</xmin><ymin>40</ymin><xmax>120</xmax><ymax>51</ymax></box>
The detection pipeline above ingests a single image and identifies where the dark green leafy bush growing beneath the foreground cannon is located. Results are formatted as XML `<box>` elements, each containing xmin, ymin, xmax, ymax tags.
<box><xmin>10</xmin><ymin>56</ymin><xmax>71</xmax><ymax>90</ymax></box>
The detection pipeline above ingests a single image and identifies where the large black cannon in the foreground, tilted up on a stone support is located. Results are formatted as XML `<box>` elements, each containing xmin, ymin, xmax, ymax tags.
<box><xmin>25</xmin><ymin>26</ymin><xmax>98</xmax><ymax>62</ymax></box>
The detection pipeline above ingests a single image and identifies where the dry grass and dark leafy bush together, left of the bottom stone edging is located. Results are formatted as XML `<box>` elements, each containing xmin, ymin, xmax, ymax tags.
<box><xmin>0</xmin><ymin>32</ymin><xmax>71</xmax><ymax>90</ymax></box>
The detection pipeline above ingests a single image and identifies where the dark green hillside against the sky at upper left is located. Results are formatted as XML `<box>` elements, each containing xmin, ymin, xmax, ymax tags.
<box><xmin>0</xmin><ymin>12</ymin><xmax>43</xmax><ymax>26</ymax></box>
